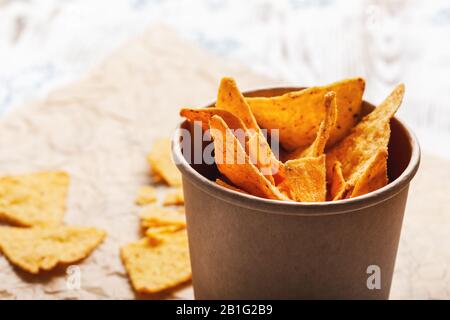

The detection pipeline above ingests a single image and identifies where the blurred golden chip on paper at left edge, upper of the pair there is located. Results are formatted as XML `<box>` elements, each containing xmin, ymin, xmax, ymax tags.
<box><xmin>0</xmin><ymin>172</ymin><xmax>69</xmax><ymax>227</ymax></box>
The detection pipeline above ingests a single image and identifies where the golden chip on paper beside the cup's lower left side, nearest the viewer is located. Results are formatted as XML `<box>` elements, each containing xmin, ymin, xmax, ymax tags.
<box><xmin>120</xmin><ymin>230</ymin><xmax>191</xmax><ymax>293</ymax></box>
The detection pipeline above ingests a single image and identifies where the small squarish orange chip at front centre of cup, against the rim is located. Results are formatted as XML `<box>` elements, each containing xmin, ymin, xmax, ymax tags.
<box><xmin>278</xmin><ymin>155</ymin><xmax>327</xmax><ymax>202</ymax></box>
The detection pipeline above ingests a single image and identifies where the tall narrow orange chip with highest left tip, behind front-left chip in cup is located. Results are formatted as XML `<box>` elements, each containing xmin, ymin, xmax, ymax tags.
<box><xmin>216</xmin><ymin>78</ymin><xmax>283</xmax><ymax>184</ymax></box>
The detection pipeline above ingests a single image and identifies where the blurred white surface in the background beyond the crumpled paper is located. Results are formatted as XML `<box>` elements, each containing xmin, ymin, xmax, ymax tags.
<box><xmin>0</xmin><ymin>0</ymin><xmax>450</xmax><ymax>158</ymax></box>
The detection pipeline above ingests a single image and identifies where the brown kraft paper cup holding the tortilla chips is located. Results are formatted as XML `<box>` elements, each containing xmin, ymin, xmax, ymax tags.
<box><xmin>172</xmin><ymin>88</ymin><xmax>420</xmax><ymax>299</ymax></box>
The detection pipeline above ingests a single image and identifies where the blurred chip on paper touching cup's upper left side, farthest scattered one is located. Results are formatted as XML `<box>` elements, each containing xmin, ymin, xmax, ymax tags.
<box><xmin>148</xmin><ymin>138</ymin><xmax>181</xmax><ymax>186</ymax></box>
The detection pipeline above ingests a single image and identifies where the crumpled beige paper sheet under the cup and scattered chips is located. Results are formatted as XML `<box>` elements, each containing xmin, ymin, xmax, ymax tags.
<box><xmin>0</xmin><ymin>27</ymin><xmax>450</xmax><ymax>299</ymax></box>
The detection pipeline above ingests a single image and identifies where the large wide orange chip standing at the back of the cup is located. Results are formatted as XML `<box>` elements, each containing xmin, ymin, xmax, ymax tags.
<box><xmin>246</xmin><ymin>78</ymin><xmax>365</xmax><ymax>151</ymax></box>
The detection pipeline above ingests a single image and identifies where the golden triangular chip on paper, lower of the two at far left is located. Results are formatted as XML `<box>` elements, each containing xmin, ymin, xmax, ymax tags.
<box><xmin>0</xmin><ymin>226</ymin><xmax>106</xmax><ymax>274</ymax></box>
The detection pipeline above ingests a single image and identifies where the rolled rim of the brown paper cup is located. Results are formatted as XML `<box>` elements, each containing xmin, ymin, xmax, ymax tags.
<box><xmin>172</xmin><ymin>87</ymin><xmax>421</xmax><ymax>216</ymax></box>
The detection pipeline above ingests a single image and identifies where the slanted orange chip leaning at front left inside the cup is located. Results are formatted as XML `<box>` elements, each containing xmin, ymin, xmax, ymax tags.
<box><xmin>209</xmin><ymin>116</ymin><xmax>286</xmax><ymax>200</ymax></box>
